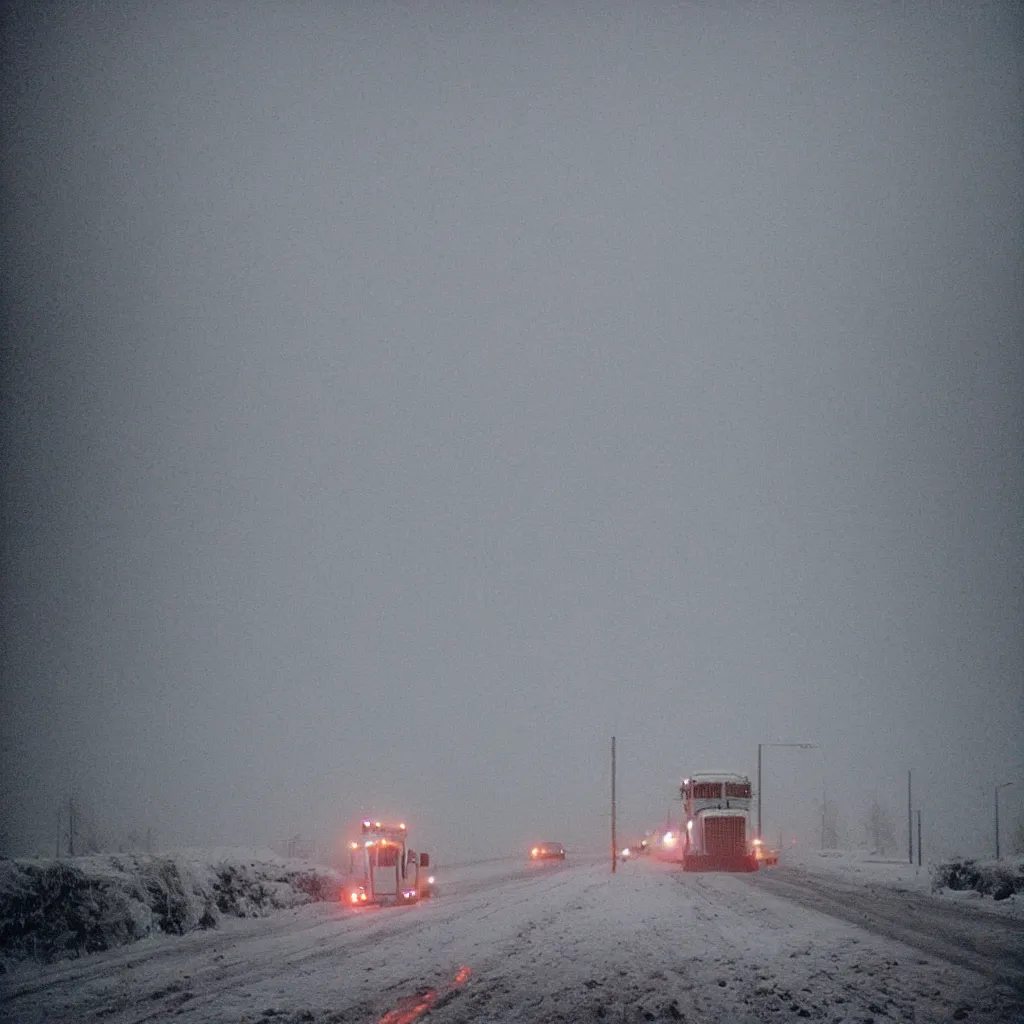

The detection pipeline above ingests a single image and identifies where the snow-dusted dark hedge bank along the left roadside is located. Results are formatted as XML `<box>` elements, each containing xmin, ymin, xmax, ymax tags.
<box><xmin>0</xmin><ymin>851</ymin><xmax>342</xmax><ymax>967</ymax></box>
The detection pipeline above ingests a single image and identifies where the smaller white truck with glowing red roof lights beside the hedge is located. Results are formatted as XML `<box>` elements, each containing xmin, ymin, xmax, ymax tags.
<box><xmin>341</xmin><ymin>819</ymin><xmax>434</xmax><ymax>907</ymax></box>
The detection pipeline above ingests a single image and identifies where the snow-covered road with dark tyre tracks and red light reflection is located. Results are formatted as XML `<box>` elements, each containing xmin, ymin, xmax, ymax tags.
<box><xmin>0</xmin><ymin>859</ymin><xmax>1024</xmax><ymax>1024</ymax></box>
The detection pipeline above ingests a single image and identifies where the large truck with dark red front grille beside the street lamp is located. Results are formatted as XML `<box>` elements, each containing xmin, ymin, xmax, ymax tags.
<box><xmin>679</xmin><ymin>772</ymin><xmax>758</xmax><ymax>871</ymax></box>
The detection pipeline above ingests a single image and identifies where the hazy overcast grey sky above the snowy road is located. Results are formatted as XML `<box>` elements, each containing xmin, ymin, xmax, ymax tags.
<box><xmin>0</xmin><ymin>2</ymin><xmax>1024</xmax><ymax>860</ymax></box>
